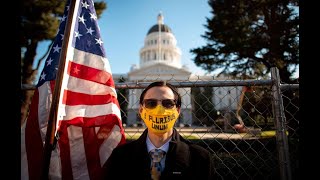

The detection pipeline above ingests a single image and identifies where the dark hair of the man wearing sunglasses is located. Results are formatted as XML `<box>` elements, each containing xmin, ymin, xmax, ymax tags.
<box><xmin>140</xmin><ymin>81</ymin><xmax>181</xmax><ymax>107</ymax></box>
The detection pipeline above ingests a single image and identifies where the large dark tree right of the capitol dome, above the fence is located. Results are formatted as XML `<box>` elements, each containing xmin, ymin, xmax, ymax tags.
<box><xmin>190</xmin><ymin>0</ymin><xmax>299</xmax><ymax>83</ymax></box>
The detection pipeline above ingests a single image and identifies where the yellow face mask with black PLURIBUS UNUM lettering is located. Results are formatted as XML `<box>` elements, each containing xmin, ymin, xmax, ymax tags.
<box><xmin>140</xmin><ymin>105</ymin><xmax>179</xmax><ymax>134</ymax></box>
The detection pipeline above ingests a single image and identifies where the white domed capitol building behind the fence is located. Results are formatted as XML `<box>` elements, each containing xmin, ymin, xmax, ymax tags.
<box><xmin>113</xmin><ymin>13</ymin><xmax>241</xmax><ymax>126</ymax></box>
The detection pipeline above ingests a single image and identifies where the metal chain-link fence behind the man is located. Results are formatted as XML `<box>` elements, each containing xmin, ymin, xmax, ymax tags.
<box><xmin>21</xmin><ymin>69</ymin><xmax>300</xmax><ymax>180</ymax></box>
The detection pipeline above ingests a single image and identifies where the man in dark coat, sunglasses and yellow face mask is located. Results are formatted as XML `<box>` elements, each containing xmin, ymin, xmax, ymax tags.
<box><xmin>104</xmin><ymin>81</ymin><xmax>214</xmax><ymax>180</ymax></box>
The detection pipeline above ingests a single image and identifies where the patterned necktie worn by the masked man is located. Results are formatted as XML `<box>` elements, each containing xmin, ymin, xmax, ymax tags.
<box><xmin>149</xmin><ymin>149</ymin><xmax>166</xmax><ymax>180</ymax></box>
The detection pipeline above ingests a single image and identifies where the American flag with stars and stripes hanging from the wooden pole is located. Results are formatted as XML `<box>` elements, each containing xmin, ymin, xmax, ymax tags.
<box><xmin>21</xmin><ymin>0</ymin><xmax>125</xmax><ymax>179</ymax></box>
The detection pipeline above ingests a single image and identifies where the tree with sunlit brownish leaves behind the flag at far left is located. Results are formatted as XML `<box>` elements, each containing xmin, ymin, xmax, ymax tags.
<box><xmin>20</xmin><ymin>0</ymin><xmax>107</xmax><ymax>122</ymax></box>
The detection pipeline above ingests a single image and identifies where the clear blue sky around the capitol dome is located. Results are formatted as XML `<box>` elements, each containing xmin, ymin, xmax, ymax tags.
<box><xmin>37</xmin><ymin>0</ymin><xmax>211</xmax><ymax>81</ymax></box>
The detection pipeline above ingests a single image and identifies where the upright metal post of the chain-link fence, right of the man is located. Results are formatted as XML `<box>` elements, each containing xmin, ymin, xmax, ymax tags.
<box><xmin>271</xmin><ymin>67</ymin><xmax>291</xmax><ymax>180</ymax></box>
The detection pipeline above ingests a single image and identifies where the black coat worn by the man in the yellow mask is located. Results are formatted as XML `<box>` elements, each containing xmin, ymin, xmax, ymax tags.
<box><xmin>104</xmin><ymin>129</ymin><xmax>214</xmax><ymax>180</ymax></box>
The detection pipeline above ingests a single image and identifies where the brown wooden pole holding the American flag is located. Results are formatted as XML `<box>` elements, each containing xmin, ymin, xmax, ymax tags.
<box><xmin>41</xmin><ymin>0</ymin><xmax>77</xmax><ymax>180</ymax></box>
